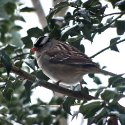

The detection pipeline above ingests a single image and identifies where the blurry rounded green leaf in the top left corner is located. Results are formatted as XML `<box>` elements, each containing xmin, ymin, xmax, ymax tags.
<box><xmin>4</xmin><ymin>2</ymin><xmax>16</xmax><ymax>15</ymax></box>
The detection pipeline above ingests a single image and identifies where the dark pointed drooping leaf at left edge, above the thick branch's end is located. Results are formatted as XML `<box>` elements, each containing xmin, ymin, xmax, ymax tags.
<box><xmin>0</xmin><ymin>50</ymin><xmax>12</xmax><ymax>76</ymax></box>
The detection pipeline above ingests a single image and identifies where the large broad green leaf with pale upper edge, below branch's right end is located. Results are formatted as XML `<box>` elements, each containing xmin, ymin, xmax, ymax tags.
<box><xmin>79</xmin><ymin>101</ymin><xmax>102</xmax><ymax>118</ymax></box>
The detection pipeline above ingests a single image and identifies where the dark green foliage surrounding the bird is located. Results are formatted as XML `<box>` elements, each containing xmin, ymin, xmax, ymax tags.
<box><xmin>0</xmin><ymin>0</ymin><xmax>125</xmax><ymax>125</ymax></box>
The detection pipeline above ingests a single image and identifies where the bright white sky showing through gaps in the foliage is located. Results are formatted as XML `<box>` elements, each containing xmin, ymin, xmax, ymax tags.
<box><xmin>21</xmin><ymin>0</ymin><xmax>125</xmax><ymax>125</ymax></box>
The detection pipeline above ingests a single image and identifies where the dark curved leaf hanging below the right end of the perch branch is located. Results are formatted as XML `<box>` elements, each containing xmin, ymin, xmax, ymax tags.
<box><xmin>63</xmin><ymin>97</ymin><xmax>75</xmax><ymax>114</ymax></box>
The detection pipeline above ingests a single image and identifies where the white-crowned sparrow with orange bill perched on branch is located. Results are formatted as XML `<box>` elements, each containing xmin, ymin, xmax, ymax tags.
<box><xmin>32</xmin><ymin>36</ymin><xmax>115</xmax><ymax>84</ymax></box>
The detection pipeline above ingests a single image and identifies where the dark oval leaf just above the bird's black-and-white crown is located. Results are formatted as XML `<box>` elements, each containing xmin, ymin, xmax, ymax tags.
<box><xmin>27</xmin><ymin>27</ymin><xmax>44</xmax><ymax>38</ymax></box>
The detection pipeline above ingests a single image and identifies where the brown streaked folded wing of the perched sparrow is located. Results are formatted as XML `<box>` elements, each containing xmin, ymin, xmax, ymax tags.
<box><xmin>46</xmin><ymin>43</ymin><xmax>98</xmax><ymax>67</ymax></box>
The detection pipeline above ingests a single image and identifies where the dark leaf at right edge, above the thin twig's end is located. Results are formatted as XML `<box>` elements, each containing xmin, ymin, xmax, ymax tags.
<box><xmin>116</xmin><ymin>20</ymin><xmax>125</xmax><ymax>35</ymax></box>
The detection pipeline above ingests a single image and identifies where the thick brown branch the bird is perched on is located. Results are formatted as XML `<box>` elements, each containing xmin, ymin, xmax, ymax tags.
<box><xmin>0</xmin><ymin>64</ymin><xmax>97</xmax><ymax>100</ymax></box>
